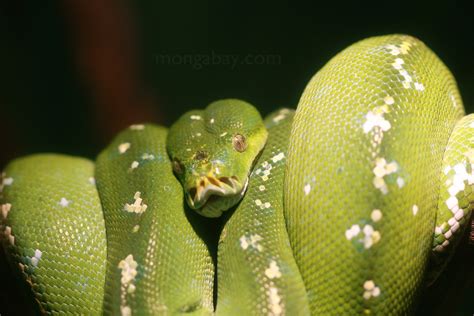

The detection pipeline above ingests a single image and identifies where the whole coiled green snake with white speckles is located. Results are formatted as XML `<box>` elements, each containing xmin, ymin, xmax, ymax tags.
<box><xmin>0</xmin><ymin>34</ymin><xmax>474</xmax><ymax>316</ymax></box>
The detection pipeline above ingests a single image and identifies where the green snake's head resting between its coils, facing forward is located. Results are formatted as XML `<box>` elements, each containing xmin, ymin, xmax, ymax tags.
<box><xmin>167</xmin><ymin>99</ymin><xmax>268</xmax><ymax>217</ymax></box>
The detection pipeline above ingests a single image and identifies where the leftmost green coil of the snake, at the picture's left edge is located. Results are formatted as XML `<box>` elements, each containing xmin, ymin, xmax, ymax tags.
<box><xmin>0</xmin><ymin>154</ymin><xmax>106</xmax><ymax>315</ymax></box>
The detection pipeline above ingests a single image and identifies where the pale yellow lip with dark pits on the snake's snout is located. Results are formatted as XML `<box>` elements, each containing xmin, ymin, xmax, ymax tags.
<box><xmin>186</xmin><ymin>176</ymin><xmax>242</xmax><ymax>210</ymax></box>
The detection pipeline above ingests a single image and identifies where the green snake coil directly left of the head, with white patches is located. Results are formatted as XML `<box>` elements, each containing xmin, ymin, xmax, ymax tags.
<box><xmin>96</xmin><ymin>125</ymin><xmax>214</xmax><ymax>315</ymax></box>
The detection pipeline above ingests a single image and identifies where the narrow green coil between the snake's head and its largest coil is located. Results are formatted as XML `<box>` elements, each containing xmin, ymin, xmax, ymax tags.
<box><xmin>216</xmin><ymin>109</ymin><xmax>309</xmax><ymax>315</ymax></box>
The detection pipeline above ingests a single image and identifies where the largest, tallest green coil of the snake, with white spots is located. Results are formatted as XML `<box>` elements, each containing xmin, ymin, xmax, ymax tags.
<box><xmin>285</xmin><ymin>35</ymin><xmax>463</xmax><ymax>315</ymax></box>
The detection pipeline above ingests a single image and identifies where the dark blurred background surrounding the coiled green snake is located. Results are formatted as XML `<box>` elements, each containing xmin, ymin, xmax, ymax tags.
<box><xmin>0</xmin><ymin>0</ymin><xmax>474</xmax><ymax>315</ymax></box>
